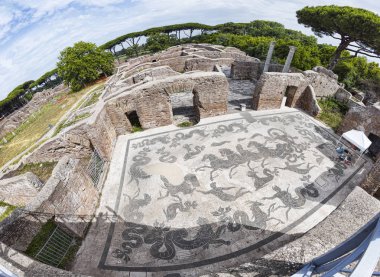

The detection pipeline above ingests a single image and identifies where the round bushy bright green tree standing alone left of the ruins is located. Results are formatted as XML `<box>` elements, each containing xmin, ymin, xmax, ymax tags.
<box><xmin>57</xmin><ymin>41</ymin><xmax>113</xmax><ymax>91</ymax></box>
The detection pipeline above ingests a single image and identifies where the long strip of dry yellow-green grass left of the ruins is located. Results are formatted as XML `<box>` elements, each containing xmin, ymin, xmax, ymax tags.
<box><xmin>0</xmin><ymin>81</ymin><xmax>101</xmax><ymax>167</ymax></box>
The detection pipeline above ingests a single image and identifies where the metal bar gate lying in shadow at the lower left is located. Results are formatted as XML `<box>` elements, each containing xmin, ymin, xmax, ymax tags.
<box><xmin>35</xmin><ymin>226</ymin><xmax>74</xmax><ymax>267</ymax></box>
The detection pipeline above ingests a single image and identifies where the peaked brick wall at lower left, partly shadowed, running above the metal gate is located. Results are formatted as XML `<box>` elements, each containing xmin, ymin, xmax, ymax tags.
<box><xmin>0</xmin><ymin>156</ymin><xmax>99</xmax><ymax>251</ymax></box>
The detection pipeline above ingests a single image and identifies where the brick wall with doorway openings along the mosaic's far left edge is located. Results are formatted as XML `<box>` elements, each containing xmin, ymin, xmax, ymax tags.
<box><xmin>108</xmin><ymin>72</ymin><xmax>228</xmax><ymax>127</ymax></box>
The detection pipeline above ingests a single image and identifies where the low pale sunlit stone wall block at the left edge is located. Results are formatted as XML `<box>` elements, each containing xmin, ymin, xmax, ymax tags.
<box><xmin>0</xmin><ymin>172</ymin><xmax>43</xmax><ymax>206</ymax></box>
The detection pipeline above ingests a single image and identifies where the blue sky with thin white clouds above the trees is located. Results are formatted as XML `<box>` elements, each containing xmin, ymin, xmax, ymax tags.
<box><xmin>0</xmin><ymin>0</ymin><xmax>380</xmax><ymax>99</ymax></box>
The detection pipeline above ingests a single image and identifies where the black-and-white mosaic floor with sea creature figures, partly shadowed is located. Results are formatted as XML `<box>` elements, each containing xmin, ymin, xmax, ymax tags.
<box><xmin>77</xmin><ymin>109</ymin><xmax>364</xmax><ymax>272</ymax></box>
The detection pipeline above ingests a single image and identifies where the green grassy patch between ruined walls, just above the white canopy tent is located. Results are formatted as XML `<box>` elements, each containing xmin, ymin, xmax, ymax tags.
<box><xmin>317</xmin><ymin>97</ymin><xmax>349</xmax><ymax>131</ymax></box>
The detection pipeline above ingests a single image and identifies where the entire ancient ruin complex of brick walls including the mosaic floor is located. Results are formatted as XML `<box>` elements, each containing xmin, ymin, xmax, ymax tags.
<box><xmin>0</xmin><ymin>44</ymin><xmax>380</xmax><ymax>276</ymax></box>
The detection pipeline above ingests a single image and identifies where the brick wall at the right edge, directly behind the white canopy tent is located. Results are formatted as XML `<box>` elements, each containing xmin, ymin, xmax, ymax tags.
<box><xmin>338</xmin><ymin>106</ymin><xmax>380</xmax><ymax>136</ymax></box>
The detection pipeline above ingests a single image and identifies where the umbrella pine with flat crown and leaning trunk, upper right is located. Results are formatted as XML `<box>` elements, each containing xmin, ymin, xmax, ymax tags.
<box><xmin>297</xmin><ymin>5</ymin><xmax>380</xmax><ymax>69</ymax></box>
